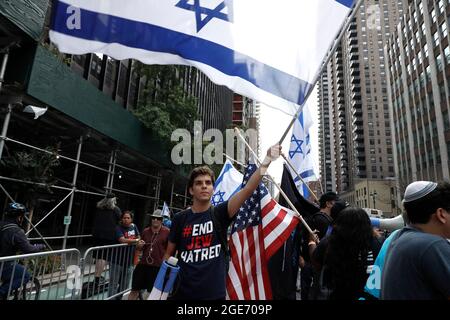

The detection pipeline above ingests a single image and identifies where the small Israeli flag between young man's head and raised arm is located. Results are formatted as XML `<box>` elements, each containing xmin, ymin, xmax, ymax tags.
<box><xmin>211</xmin><ymin>160</ymin><xmax>244</xmax><ymax>206</ymax></box>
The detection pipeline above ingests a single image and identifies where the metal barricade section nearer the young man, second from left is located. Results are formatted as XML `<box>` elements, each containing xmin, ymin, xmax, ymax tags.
<box><xmin>80</xmin><ymin>244</ymin><xmax>136</xmax><ymax>300</ymax></box>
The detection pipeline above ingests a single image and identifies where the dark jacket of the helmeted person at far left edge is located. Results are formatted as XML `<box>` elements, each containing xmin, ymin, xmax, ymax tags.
<box><xmin>0</xmin><ymin>220</ymin><xmax>42</xmax><ymax>257</ymax></box>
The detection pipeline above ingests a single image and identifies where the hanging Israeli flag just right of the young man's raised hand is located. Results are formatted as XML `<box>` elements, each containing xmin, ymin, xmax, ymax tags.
<box><xmin>287</xmin><ymin>100</ymin><xmax>316</xmax><ymax>198</ymax></box>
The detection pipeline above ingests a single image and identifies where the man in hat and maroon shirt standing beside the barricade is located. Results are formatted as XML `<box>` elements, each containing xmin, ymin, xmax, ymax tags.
<box><xmin>128</xmin><ymin>209</ymin><xmax>170</xmax><ymax>300</ymax></box>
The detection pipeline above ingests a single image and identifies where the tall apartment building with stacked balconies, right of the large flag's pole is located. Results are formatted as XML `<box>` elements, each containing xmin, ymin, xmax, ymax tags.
<box><xmin>319</xmin><ymin>0</ymin><xmax>406</xmax><ymax>193</ymax></box>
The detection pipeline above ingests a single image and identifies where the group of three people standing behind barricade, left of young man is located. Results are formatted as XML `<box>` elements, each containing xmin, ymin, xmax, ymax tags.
<box><xmin>92</xmin><ymin>194</ymin><xmax>170</xmax><ymax>300</ymax></box>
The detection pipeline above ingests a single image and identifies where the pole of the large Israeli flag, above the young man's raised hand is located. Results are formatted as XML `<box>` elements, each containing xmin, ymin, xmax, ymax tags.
<box><xmin>278</xmin><ymin>0</ymin><xmax>363</xmax><ymax>145</ymax></box>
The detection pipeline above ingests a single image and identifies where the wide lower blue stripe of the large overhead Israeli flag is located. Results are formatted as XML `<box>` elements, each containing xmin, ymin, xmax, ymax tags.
<box><xmin>52</xmin><ymin>1</ymin><xmax>312</xmax><ymax>105</ymax></box>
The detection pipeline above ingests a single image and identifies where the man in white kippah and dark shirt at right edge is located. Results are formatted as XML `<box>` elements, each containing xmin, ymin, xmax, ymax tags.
<box><xmin>381</xmin><ymin>181</ymin><xmax>450</xmax><ymax>300</ymax></box>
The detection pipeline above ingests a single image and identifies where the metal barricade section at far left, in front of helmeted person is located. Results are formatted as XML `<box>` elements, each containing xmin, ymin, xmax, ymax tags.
<box><xmin>0</xmin><ymin>249</ymin><xmax>81</xmax><ymax>300</ymax></box>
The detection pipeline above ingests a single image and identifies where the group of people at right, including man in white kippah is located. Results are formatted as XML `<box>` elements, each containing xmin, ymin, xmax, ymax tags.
<box><xmin>300</xmin><ymin>181</ymin><xmax>450</xmax><ymax>300</ymax></box>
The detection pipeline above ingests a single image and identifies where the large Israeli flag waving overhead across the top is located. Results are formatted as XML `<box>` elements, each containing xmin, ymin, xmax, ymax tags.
<box><xmin>50</xmin><ymin>0</ymin><xmax>355</xmax><ymax>112</ymax></box>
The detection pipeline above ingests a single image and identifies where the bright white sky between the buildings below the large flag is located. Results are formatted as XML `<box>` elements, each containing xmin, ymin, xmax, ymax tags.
<box><xmin>260</xmin><ymin>86</ymin><xmax>319</xmax><ymax>183</ymax></box>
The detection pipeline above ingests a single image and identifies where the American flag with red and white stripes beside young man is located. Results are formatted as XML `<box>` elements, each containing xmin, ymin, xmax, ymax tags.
<box><xmin>227</xmin><ymin>164</ymin><xmax>299</xmax><ymax>300</ymax></box>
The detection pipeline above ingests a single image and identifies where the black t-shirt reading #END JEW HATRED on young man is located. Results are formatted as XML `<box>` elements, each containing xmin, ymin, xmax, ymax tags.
<box><xmin>169</xmin><ymin>201</ymin><xmax>232</xmax><ymax>300</ymax></box>
